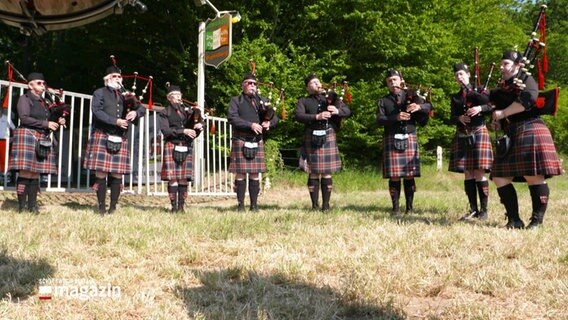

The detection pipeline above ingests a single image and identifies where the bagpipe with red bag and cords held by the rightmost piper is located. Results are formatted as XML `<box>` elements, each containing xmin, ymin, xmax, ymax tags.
<box><xmin>490</xmin><ymin>4</ymin><xmax>559</xmax><ymax>116</ymax></box>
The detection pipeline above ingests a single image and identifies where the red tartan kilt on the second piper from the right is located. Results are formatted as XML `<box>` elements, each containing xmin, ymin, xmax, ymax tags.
<box><xmin>448</xmin><ymin>126</ymin><xmax>493</xmax><ymax>173</ymax></box>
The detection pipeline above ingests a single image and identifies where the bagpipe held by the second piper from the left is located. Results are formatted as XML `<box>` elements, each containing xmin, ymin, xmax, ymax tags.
<box><xmin>110</xmin><ymin>55</ymin><xmax>154</xmax><ymax>125</ymax></box>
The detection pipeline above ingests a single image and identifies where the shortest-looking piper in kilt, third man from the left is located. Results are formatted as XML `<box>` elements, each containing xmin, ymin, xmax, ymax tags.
<box><xmin>158</xmin><ymin>85</ymin><xmax>203</xmax><ymax>212</ymax></box>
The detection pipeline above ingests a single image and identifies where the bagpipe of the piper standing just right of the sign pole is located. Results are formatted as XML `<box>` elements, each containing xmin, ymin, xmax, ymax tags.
<box><xmin>249</xmin><ymin>59</ymin><xmax>287</xmax><ymax>122</ymax></box>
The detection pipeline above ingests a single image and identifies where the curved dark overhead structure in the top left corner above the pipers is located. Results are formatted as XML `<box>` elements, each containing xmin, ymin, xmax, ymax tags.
<box><xmin>0</xmin><ymin>0</ymin><xmax>148</xmax><ymax>35</ymax></box>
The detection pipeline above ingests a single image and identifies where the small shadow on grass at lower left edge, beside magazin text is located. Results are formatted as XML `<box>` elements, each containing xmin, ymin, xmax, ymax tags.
<box><xmin>0</xmin><ymin>250</ymin><xmax>55</xmax><ymax>301</ymax></box>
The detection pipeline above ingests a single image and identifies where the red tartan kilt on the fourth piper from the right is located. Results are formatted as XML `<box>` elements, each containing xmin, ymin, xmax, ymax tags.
<box><xmin>300</xmin><ymin>128</ymin><xmax>341</xmax><ymax>174</ymax></box>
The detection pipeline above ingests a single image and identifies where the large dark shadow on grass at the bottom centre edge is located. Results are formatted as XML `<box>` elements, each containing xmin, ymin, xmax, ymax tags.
<box><xmin>175</xmin><ymin>268</ymin><xmax>406</xmax><ymax>319</ymax></box>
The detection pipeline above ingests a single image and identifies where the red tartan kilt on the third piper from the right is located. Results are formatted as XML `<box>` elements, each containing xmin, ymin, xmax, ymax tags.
<box><xmin>383</xmin><ymin>133</ymin><xmax>420</xmax><ymax>179</ymax></box>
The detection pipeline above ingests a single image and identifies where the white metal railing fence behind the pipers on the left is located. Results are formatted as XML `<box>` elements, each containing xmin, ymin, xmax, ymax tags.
<box><xmin>0</xmin><ymin>80</ymin><xmax>234</xmax><ymax>195</ymax></box>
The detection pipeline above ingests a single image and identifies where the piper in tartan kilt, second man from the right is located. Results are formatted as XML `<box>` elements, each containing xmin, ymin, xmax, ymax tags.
<box><xmin>449</xmin><ymin>62</ymin><xmax>493</xmax><ymax>220</ymax></box>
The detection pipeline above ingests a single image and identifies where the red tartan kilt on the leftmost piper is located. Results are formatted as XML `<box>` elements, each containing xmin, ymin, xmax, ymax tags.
<box><xmin>9</xmin><ymin>128</ymin><xmax>57</xmax><ymax>174</ymax></box>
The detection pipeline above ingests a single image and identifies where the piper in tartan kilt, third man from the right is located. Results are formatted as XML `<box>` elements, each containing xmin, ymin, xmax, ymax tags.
<box><xmin>377</xmin><ymin>70</ymin><xmax>432</xmax><ymax>217</ymax></box>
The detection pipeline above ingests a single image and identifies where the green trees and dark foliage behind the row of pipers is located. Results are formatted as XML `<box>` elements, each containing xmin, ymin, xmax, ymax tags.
<box><xmin>0</xmin><ymin>0</ymin><xmax>568</xmax><ymax>167</ymax></box>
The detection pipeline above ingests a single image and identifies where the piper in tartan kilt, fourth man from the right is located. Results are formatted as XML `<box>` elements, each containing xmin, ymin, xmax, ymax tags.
<box><xmin>295</xmin><ymin>74</ymin><xmax>351</xmax><ymax>211</ymax></box>
